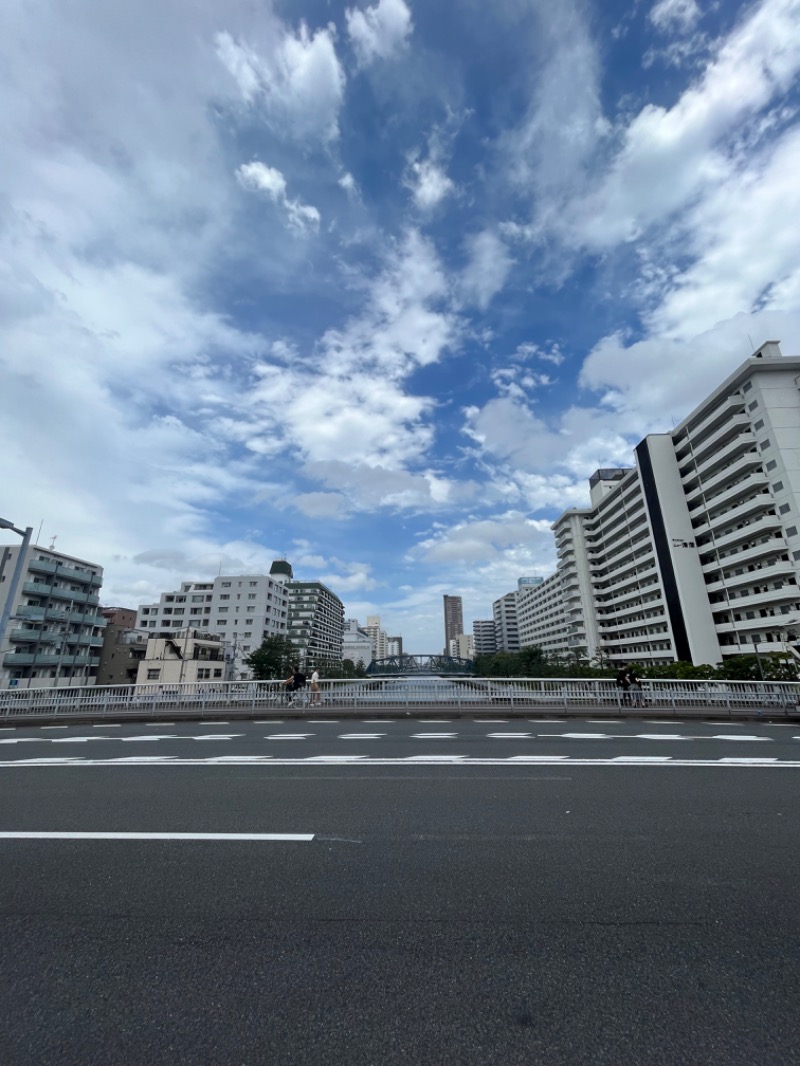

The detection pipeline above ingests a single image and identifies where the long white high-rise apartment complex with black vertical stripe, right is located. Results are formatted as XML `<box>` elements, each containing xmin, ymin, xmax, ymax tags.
<box><xmin>519</xmin><ymin>341</ymin><xmax>800</xmax><ymax>664</ymax></box>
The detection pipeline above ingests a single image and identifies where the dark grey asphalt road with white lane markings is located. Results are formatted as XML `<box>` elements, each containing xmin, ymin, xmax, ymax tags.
<box><xmin>0</xmin><ymin>720</ymin><xmax>800</xmax><ymax>1066</ymax></box>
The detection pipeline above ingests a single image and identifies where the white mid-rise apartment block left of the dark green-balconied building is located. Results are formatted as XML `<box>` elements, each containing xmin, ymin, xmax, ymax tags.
<box><xmin>135</xmin><ymin>574</ymin><xmax>289</xmax><ymax>680</ymax></box>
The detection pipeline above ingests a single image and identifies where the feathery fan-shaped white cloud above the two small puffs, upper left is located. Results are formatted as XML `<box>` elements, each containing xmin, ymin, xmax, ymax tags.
<box><xmin>217</xmin><ymin>22</ymin><xmax>346</xmax><ymax>142</ymax></box>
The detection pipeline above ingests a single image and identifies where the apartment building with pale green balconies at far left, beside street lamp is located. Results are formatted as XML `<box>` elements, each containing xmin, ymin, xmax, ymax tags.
<box><xmin>0</xmin><ymin>544</ymin><xmax>106</xmax><ymax>689</ymax></box>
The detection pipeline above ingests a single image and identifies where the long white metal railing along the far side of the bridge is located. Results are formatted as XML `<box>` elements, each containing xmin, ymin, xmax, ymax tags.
<box><xmin>0</xmin><ymin>677</ymin><xmax>800</xmax><ymax>722</ymax></box>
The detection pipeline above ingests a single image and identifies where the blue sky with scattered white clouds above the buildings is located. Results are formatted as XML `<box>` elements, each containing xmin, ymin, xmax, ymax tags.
<box><xmin>0</xmin><ymin>0</ymin><xmax>800</xmax><ymax>652</ymax></box>
